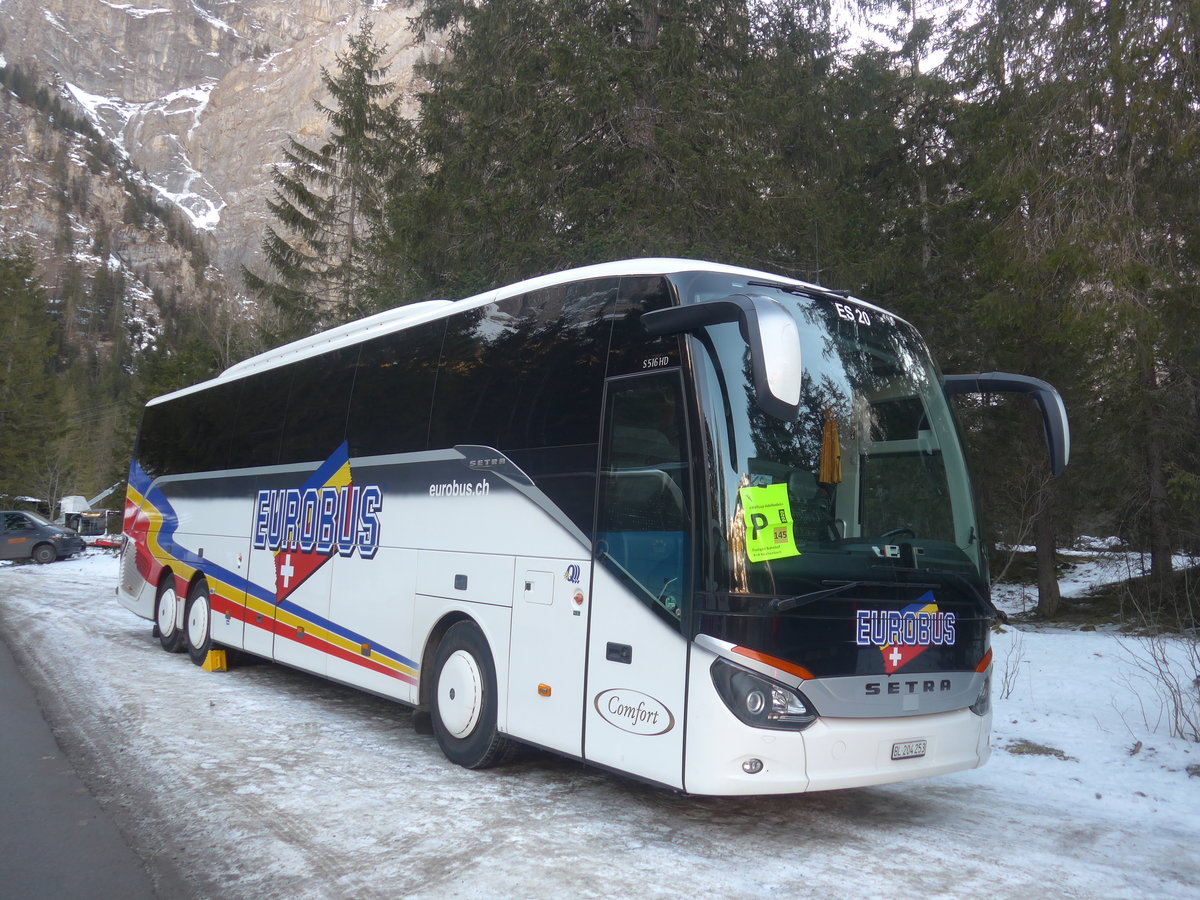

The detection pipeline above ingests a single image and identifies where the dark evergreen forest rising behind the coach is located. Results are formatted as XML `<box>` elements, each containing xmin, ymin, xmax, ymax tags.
<box><xmin>0</xmin><ymin>0</ymin><xmax>1200</xmax><ymax>617</ymax></box>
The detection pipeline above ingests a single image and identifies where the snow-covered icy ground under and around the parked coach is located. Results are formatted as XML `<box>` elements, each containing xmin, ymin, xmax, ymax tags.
<box><xmin>0</xmin><ymin>551</ymin><xmax>1200</xmax><ymax>900</ymax></box>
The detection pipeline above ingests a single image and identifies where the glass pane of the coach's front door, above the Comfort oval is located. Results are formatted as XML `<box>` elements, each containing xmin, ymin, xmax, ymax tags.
<box><xmin>596</xmin><ymin>372</ymin><xmax>691</xmax><ymax>619</ymax></box>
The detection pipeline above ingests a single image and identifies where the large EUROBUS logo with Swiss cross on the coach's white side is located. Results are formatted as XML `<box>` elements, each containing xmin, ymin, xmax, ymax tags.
<box><xmin>253</xmin><ymin>444</ymin><xmax>383</xmax><ymax>602</ymax></box>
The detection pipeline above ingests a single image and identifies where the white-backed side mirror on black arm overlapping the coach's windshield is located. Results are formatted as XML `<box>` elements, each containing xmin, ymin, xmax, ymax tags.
<box><xmin>642</xmin><ymin>294</ymin><xmax>804</xmax><ymax>421</ymax></box>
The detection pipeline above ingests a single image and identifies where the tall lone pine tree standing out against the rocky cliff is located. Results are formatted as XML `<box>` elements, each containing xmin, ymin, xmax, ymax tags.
<box><xmin>244</xmin><ymin>19</ymin><xmax>398</xmax><ymax>337</ymax></box>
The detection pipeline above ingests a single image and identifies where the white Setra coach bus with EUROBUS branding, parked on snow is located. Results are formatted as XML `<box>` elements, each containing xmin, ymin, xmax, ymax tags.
<box><xmin>118</xmin><ymin>259</ymin><xmax>1069</xmax><ymax>794</ymax></box>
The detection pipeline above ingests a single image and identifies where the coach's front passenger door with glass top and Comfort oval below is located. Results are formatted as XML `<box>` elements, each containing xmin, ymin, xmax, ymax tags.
<box><xmin>584</xmin><ymin>370</ymin><xmax>691</xmax><ymax>787</ymax></box>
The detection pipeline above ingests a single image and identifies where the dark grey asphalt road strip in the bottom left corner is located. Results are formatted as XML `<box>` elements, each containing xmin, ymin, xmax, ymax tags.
<box><xmin>0</xmin><ymin>619</ymin><xmax>158</xmax><ymax>900</ymax></box>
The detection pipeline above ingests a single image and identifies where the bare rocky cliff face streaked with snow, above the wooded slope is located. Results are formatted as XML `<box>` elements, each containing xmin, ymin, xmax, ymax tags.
<box><xmin>0</xmin><ymin>0</ymin><xmax>431</xmax><ymax>278</ymax></box>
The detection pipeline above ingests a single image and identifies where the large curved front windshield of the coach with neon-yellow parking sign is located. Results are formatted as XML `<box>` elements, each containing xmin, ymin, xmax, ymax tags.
<box><xmin>680</xmin><ymin>274</ymin><xmax>986</xmax><ymax>609</ymax></box>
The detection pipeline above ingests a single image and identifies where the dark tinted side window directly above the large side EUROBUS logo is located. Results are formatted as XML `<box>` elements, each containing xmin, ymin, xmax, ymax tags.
<box><xmin>280</xmin><ymin>347</ymin><xmax>359</xmax><ymax>463</ymax></box>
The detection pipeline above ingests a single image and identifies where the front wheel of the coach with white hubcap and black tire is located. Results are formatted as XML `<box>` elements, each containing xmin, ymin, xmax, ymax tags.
<box><xmin>432</xmin><ymin>622</ymin><xmax>510</xmax><ymax>769</ymax></box>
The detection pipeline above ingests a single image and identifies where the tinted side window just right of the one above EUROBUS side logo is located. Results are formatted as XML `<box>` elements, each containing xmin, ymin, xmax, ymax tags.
<box><xmin>348</xmin><ymin>320</ymin><xmax>445</xmax><ymax>456</ymax></box>
